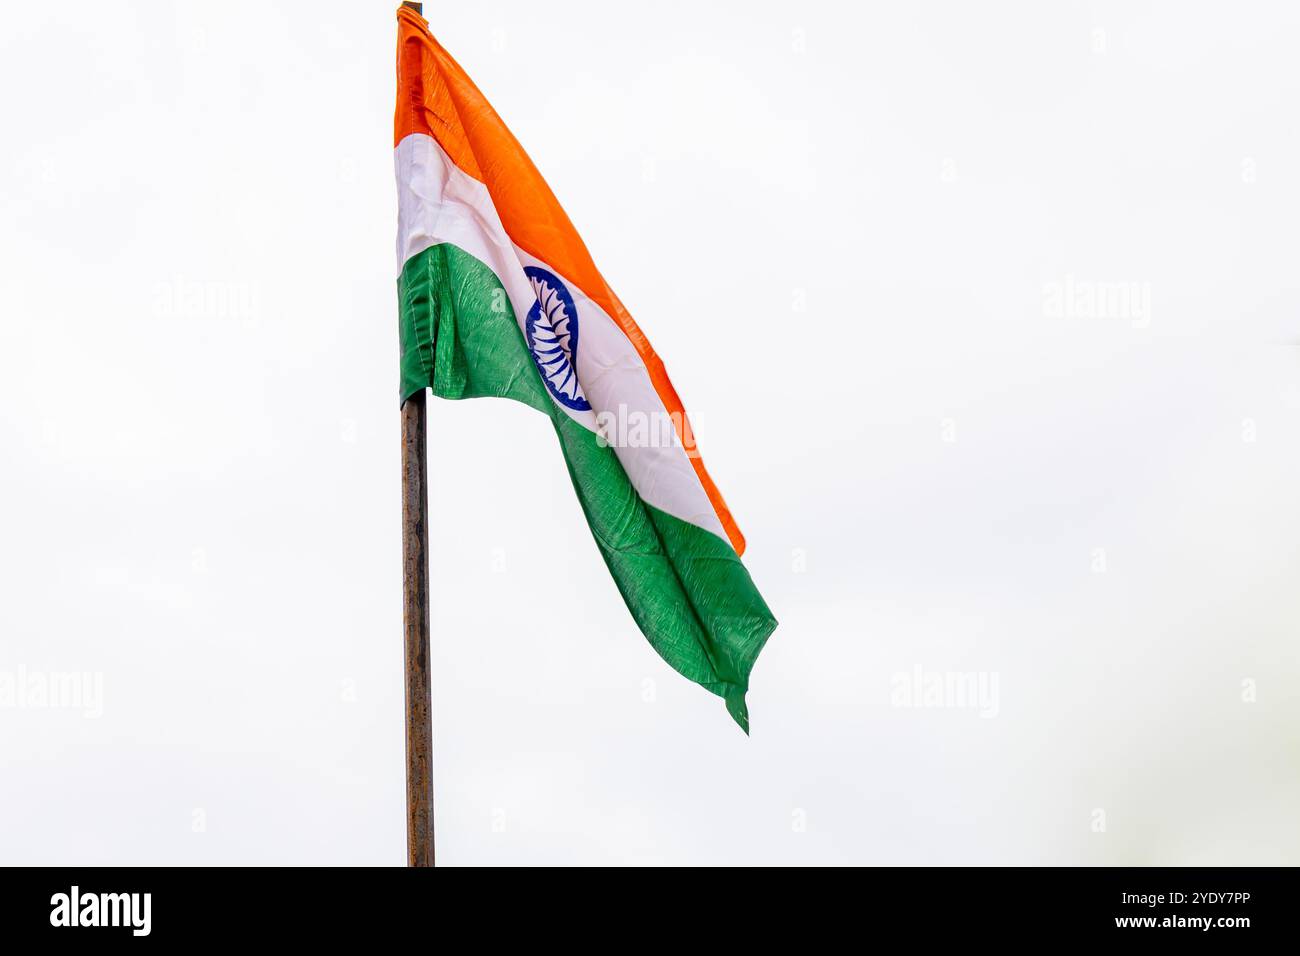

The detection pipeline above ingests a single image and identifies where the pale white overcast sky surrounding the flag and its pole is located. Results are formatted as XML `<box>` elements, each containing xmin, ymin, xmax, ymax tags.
<box><xmin>0</xmin><ymin>0</ymin><xmax>1300</xmax><ymax>864</ymax></box>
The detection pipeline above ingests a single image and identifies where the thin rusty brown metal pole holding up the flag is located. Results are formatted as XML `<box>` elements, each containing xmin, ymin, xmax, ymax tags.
<box><xmin>402</xmin><ymin>3</ymin><xmax>433</xmax><ymax>866</ymax></box>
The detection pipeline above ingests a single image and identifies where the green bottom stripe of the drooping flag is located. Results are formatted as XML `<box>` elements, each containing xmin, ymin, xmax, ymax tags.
<box><xmin>398</xmin><ymin>243</ymin><xmax>776</xmax><ymax>734</ymax></box>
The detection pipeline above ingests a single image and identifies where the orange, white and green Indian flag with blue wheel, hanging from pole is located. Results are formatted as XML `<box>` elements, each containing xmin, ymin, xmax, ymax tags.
<box><xmin>384</xmin><ymin>7</ymin><xmax>776</xmax><ymax>732</ymax></box>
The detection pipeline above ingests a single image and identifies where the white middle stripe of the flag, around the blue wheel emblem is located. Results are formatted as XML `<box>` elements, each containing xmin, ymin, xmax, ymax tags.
<box><xmin>395</xmin><ymin>133</ymin><xmax>727</xmax><ymax>541</ymax></box>
